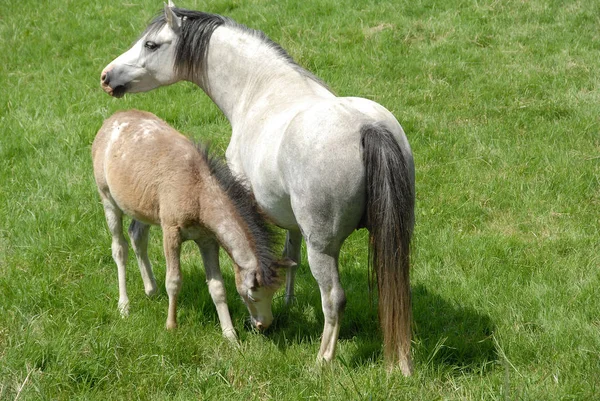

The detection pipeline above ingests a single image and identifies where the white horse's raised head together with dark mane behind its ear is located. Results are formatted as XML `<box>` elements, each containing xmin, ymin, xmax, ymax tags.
<box><xmin>100</xmin><ymin>1</ymin><xmax>227</xmax><ymax>97</ymax></box>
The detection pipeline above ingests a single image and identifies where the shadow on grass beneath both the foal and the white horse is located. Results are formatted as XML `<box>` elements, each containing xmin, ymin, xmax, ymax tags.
<box><xmin>161</xmin><ymin>247</ymin><xmax>498</xmax><ymax>371</ymax></box>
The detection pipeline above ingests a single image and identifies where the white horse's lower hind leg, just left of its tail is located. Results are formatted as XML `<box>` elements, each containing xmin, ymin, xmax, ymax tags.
<box><xmin>307</xmin><ymin>243</ymin><xmax>346</xmax><ymax>362</ymax></box>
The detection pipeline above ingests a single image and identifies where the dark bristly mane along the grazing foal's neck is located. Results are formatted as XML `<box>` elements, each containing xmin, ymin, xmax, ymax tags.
<box><xmin>196</xmin><ymin>143</ymin><xmax>279</xmax><ymax>287</ymax></box>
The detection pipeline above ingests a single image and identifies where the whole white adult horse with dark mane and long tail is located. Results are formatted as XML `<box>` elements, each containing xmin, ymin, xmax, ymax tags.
<box><xmin>101</xmin><ymin>2</ymin><xmax>414</xmax><ymax>375</ymax></box>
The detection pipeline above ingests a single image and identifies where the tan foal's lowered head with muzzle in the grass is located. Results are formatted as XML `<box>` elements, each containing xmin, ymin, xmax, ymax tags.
<box><xmin>236</xmin><ymin>258</ymin><xmax>296</xmax><ymax>331</ymax></box>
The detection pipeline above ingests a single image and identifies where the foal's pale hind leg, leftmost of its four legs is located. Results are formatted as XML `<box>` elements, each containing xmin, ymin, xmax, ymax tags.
<box><xmin>102</xmin><ymin>198</ymin><xmax>129</xmax><ymax>317</ymax></box>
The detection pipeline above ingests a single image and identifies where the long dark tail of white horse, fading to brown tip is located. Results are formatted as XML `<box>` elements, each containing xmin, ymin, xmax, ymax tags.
<box><xmin>361</xmin><ymin>124</ymin><xmax>415</xmax><ymax>375</ymax></box>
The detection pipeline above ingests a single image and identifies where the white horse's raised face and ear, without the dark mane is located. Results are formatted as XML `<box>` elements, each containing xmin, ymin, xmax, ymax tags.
<box><xmin>100</xmin><ymin>1</ymin><xmax>182</xmax><ymax>97</ymax></box>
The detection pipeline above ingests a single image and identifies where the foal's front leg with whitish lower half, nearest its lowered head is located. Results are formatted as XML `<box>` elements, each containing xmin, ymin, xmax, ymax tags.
<box><xmin>196</xmin><ymin>239</ymin><xmax>238</xmax><ymax>344</ymax></box>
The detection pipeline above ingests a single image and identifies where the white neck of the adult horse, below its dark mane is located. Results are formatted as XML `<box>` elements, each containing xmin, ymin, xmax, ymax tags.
<box><xmin>197</xmin><ymin>26</ymin><xmax>333</xmax><ymax>127</ymax></box>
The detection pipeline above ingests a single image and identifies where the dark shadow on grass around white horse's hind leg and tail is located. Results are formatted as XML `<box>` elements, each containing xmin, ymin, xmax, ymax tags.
<box><xmin>267</xmin><ymin>271</ymin><xmax>498</xmax><ymax>371</ymax></box>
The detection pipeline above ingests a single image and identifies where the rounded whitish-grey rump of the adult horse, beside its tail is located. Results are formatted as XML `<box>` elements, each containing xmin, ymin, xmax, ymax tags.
<box><xmin>278</xmin><ymin>98</ymin><xmax>412</xmax><ymax>246</ymax></box>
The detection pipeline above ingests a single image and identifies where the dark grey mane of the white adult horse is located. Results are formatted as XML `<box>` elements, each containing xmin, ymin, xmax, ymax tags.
<box><xmin>142</xmin><ymin>8</ymin><xmax>329</xmax><ymax>90</ymax></box>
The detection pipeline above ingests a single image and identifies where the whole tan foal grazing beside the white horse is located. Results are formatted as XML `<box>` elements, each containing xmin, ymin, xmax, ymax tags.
<box><xmin>92</xmin><ymin>110</ymin><xmax>290</xmax><ymax>341</ymax></box>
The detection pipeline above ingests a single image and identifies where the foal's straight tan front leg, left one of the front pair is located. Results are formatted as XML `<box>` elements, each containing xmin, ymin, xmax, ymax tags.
<box><xmin>163</xmin><ymin>227</ymin><xmax>182</xmax><ymax>329</ymax></box>
